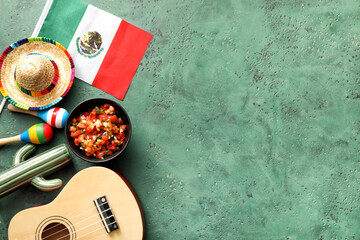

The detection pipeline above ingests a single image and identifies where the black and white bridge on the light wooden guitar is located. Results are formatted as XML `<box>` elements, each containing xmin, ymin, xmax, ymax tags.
<box><xmin>94</xmin><ymin>196</ymin><xmax>119</xmax><ymax>233</ymax></box>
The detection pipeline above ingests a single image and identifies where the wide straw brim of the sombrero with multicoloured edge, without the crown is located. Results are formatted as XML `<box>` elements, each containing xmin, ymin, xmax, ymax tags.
<box><xmin>0</xmin><ymin>37</ymin><xmax>75</xmax><ymax>110</ymax></box>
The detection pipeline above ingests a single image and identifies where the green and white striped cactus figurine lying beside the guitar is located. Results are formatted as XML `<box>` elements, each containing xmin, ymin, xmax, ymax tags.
<box><xmin>0</xmin><ymin>144</ymin><xmax>71</xmax><ymax>197</ymax></box>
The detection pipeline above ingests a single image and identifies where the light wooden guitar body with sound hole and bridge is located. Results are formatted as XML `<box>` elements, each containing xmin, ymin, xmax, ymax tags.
<box><xmin>8</xmin><ymin>167</ymin><xmax>144</xmax><ymax>240</ymax></box>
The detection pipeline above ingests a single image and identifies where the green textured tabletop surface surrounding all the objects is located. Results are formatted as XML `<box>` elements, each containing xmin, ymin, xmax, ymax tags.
<box><xmin>0</xmin><ymin>0</ymin><xmax>360</xmax><ymax>239</ymax></box>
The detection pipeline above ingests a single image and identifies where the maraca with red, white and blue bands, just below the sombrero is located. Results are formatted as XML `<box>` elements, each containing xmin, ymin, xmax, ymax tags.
<box><xmin>8</xmin><ymin>104</ymin><xmax>69</xmax><ymax>128</ymax></box>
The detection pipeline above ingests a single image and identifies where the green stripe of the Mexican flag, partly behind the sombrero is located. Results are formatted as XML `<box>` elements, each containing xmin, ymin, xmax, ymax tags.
<box><xmin>38</xmin><ymin>0</ymin><xmax>89</xmax><ymax>48</ymax></box>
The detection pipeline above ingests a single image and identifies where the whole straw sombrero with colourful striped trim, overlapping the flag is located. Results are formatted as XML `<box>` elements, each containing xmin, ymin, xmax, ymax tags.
<box><xmin>0</xmin><ymin>37</ymin><xmax>75</xmax><ymax>110</ymax></box>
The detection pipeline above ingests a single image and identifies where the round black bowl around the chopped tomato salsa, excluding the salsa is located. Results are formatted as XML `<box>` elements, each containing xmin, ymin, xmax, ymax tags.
<box><xmin>65</xmin><ymin>98</ymin><xmax>131</xmax><ymax>163</ymax></box>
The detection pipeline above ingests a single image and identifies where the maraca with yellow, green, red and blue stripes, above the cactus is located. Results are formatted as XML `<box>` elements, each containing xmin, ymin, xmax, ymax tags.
<box><xmin>0</xmin><ymin>123</ymin><xmax>53</xmax><ymax>146</ymax></box>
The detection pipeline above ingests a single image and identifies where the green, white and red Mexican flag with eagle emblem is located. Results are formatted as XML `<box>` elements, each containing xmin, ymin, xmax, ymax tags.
<box><xmin>32</xmin><ymin>0</ymin><xmax>152</xmax><ymax>100</ymax></box>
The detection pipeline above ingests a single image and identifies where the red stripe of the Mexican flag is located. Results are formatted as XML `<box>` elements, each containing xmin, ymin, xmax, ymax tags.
<box><xmin>92</xmin><ymin>20</ymin><xmax>152</xmax><ymax>100</ymax></box>
